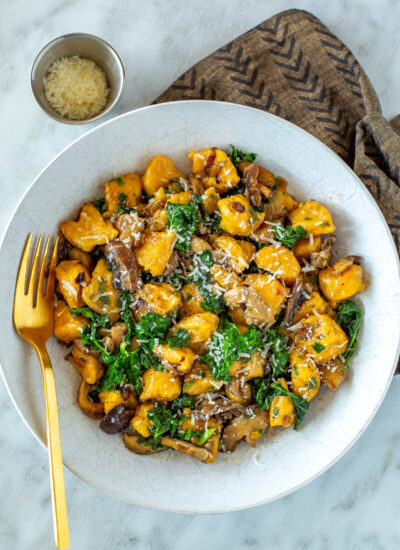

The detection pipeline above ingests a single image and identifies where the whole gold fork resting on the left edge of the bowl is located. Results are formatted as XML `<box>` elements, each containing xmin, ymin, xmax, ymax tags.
<box><xmin>14</xmin><ymin>234</ymin><xmax>69</xmax><ymax>548</ymax></box>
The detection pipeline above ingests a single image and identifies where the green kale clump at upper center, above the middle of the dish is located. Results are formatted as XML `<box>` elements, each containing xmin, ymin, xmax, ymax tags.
<box><xmin>166</xmin><ymin>202</ymin><xmax>199</xmax><ymax>254</ymax></box>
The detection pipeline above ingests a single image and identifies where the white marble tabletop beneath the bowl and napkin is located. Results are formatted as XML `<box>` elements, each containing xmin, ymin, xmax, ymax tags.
<box><xmin>0</xmin><ymin>0</ymin><xmax>400</xmax><ymax>550</ymax></box>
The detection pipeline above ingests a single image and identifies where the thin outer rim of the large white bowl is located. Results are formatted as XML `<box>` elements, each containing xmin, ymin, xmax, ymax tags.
<box><xmin>0</xmin><ymin>100</ymin><xmax>400</xmax><ymax>515</ymax></box>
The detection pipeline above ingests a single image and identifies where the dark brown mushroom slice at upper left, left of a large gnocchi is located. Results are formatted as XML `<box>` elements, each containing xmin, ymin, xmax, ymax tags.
<box><xmin>104</xmin><ymin>240</ymin><xmax>140</xmax><ymax>292</ymax></box>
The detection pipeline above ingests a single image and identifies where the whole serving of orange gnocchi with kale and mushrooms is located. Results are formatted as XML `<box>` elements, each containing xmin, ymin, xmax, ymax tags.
<box><xmin>54</xmin><ymin>146</ymin><xmax>365</xmax><ymax>463</ymax></box>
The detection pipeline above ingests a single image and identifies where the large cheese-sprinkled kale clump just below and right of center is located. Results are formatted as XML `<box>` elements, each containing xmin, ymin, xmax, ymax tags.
<box><xmin>200</xmin><ymin>317</ymin><xmax>265</xmax><ymax>382</ymax></box>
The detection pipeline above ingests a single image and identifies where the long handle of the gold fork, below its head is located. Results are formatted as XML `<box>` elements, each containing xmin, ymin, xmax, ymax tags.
<box><xmin>36</xmin><ymin>345</ymin><xmax>69</xmax><ymax>549</ymax></box>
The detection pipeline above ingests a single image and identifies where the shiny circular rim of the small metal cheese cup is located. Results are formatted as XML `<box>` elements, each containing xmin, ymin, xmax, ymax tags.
<box><xmin>30</xmin><ymin>32</ymin><xmax>126</xmax><ymax>126</ymax></box>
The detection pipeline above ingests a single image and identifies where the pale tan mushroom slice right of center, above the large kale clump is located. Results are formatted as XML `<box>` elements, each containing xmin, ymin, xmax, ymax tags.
<box><xmin>224</xmin><ymin>286</ymin><xmax>275</xmax><ymax>325</ymax></box>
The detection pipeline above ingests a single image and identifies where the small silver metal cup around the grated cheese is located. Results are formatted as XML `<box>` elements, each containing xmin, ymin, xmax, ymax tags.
<box><xmin>31</xmin><ymin>33</ymin><xmax>125</xmax><ymax>124</ymax></box>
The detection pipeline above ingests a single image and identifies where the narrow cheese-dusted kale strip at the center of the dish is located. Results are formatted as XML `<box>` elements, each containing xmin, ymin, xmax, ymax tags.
<box><xmin>187</xmin><ymin>250</ymin><xmax>225</xmax><ymax>313</ymax></box>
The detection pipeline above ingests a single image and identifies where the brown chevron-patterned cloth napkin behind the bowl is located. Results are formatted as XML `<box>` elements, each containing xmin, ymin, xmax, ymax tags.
<box><xmin>156</xmin><ymin>10</ymin><xmax>400</xmax><ymax>251</ymax></box>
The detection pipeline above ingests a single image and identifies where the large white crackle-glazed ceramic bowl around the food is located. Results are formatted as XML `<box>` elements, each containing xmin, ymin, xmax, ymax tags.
<box><xmin>0</xmin><ymin>101</ymin><xmax>400</xmax><ymax>513</ymax></box>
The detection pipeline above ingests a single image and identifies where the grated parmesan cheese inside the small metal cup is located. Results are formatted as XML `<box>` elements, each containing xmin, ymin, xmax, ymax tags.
<box><xmin>43</xmin><ymin>55</ymin><xmax>110</xmax><ymax>120</ymax></box>
